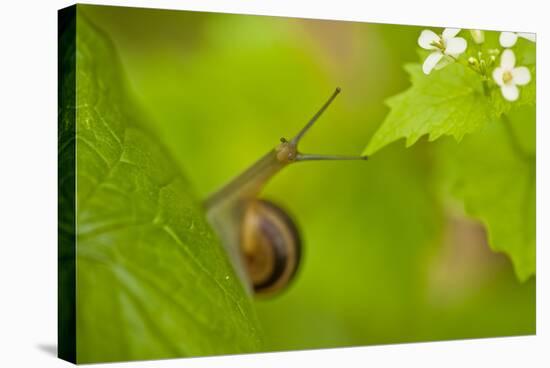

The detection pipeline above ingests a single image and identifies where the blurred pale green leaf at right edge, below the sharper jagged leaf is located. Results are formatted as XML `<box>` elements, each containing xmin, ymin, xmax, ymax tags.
<box><xmin>438</xmin><ymin>106</ymin><xmax>536</xmax><ymax>280</ymax></box>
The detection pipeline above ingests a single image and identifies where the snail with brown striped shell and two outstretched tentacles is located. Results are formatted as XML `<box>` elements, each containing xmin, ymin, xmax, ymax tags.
<box><xmin>204</xmin><ymin>88</ymin><xmax>367</xmax><ymax>295</ymax></box>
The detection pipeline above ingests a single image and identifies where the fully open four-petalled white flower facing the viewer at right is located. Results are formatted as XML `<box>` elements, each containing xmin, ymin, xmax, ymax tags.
<box><xmin>493</xmin><ymin>49</ymin><xmax>531</xmax><ymax>101</ymax></box>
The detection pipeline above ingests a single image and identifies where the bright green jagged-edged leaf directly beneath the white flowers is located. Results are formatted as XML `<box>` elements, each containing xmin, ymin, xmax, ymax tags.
<box><xmin>365</xmin><ymin>63</ymin><xmax>488</xmax><ymax>155</ymax></box>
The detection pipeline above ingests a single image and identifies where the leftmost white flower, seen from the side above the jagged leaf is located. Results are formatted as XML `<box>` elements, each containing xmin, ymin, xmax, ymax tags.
<box><xmin>418</xmin><ymin>28</ymin><xmax>468</xmax><ymax>74</ymax></box>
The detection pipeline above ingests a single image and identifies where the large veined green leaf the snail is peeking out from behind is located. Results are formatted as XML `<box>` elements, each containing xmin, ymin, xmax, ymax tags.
<box><xmin>69</xmin><ymin>9</ymin><xmax>261</xmax><ymax>363</ymax></box>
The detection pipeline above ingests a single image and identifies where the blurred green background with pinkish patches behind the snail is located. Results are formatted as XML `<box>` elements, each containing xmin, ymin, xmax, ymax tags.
<box><xmin>80</xmin><ymin>6</ymin><xmax>535</xmax><ymax>350</ymax></box>
